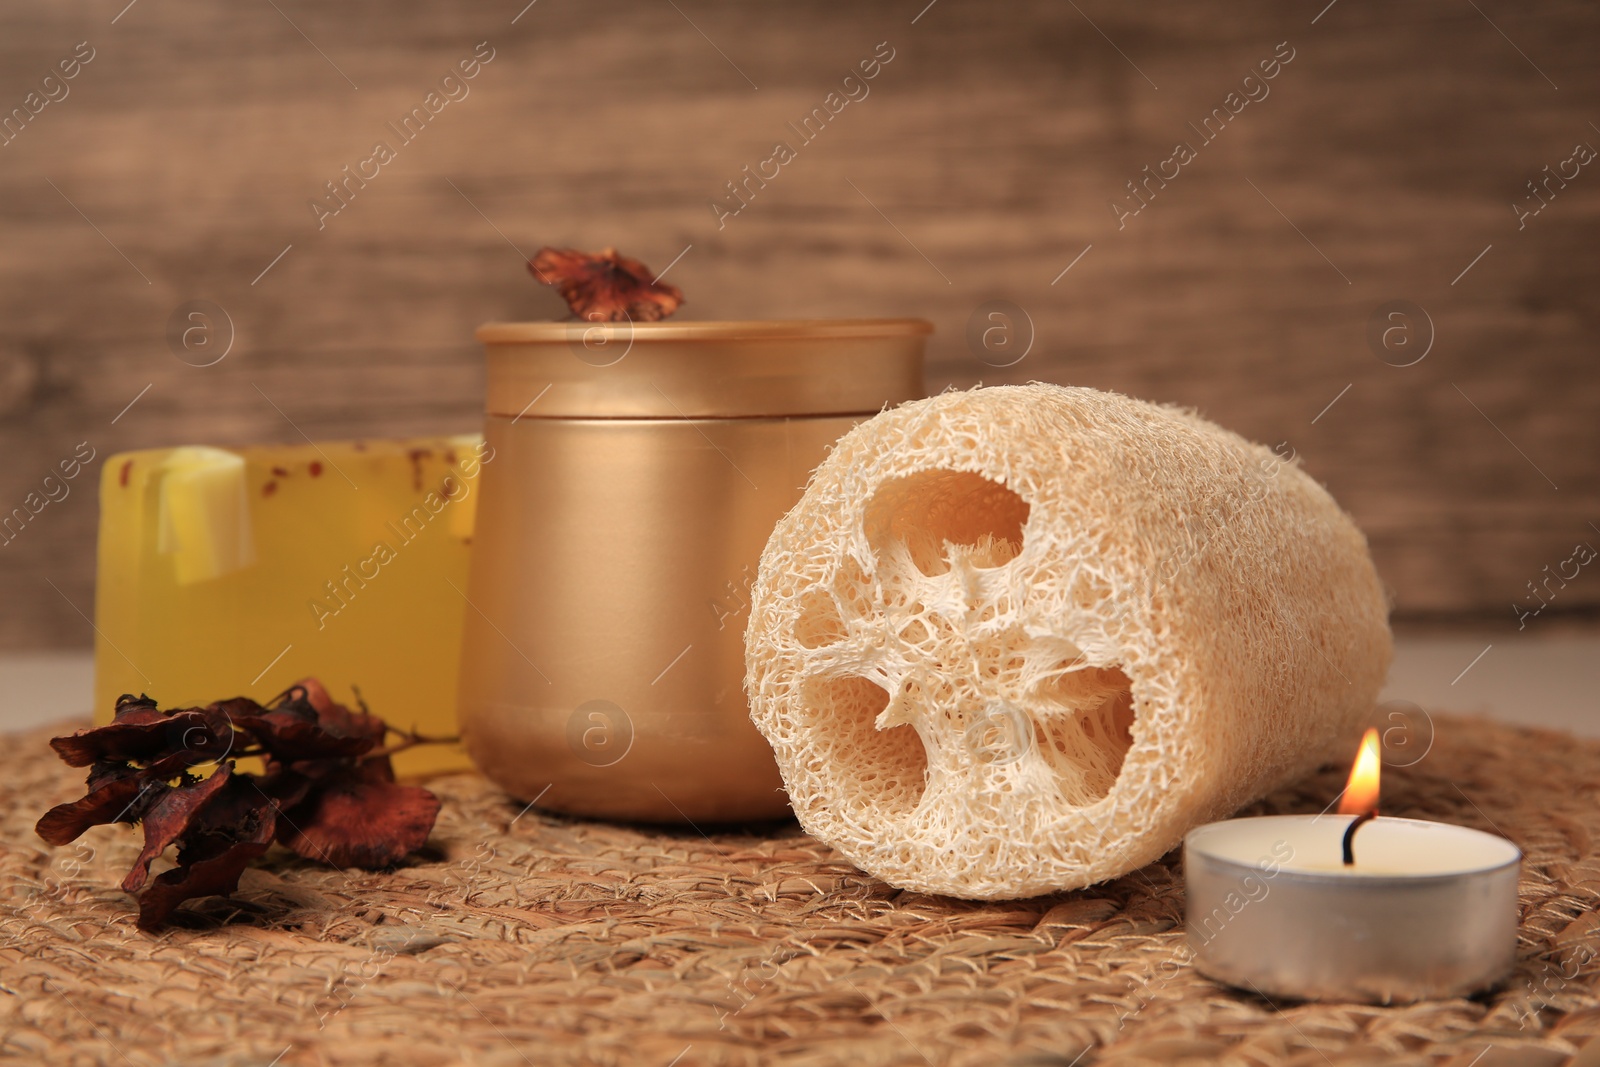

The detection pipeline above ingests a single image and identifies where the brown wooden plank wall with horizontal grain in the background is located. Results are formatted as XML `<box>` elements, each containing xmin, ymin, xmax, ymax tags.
<box><xmin>0</xmin><ymin>0</ymin><xmax>1600</xmax><ymax>648</ymax></box>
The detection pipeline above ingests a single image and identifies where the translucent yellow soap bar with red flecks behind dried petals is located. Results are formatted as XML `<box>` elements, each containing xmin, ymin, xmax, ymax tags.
<box><xmin>94</xmin><ymin>435</ymin><xmax>493</xmax><ymax>774</ymax></box>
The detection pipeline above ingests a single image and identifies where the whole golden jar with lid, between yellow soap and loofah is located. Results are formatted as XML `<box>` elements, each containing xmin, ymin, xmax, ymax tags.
<box><xmin>459</xmin><ymin>318</ymin><xmax>933</xmax><ymax>822</ymax></box>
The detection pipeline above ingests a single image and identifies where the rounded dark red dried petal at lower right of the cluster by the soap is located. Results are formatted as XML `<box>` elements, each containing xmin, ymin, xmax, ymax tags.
<box><xmin>278</xmin><ymin>758</ymin><xmax>438</xmax><ymax>869</ymax></box>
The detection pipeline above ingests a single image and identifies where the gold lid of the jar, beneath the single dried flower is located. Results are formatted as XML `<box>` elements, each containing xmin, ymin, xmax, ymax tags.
<box><xmin>477</xmin><ymin>318</ymin><xmax>933</xmax><ymax>419</ymax></box>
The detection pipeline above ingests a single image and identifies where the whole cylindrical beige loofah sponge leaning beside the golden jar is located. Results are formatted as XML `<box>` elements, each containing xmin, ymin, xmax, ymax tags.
<box><xmin>746</xmin><ymin>384</ymin><xmax>1392</xmax><ymax>899</ymax></box>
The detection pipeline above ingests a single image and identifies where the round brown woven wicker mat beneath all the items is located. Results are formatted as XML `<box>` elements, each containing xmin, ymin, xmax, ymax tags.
<box><xmin>0</xmin><ymin>715</ymin><xmax>1600</xmax><ymax>1067</ymax></box>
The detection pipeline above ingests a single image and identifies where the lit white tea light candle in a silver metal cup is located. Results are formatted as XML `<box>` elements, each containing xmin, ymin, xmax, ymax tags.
<box><xmin>1184</xmin><ymin>731</ymin><xmax>1522</xmax><ymax>1003</ymax></box>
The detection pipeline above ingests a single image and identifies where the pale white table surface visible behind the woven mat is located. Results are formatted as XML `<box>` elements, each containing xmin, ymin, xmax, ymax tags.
<box><xmin>0</xmin><ymin>627</ymin><xmax>1600</xmax><ymax>737</ymax></box>
